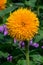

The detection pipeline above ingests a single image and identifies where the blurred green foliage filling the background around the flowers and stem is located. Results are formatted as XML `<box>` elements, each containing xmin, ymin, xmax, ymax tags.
<box><xmin>0</xmin><ymin>0</ymin><xmax>43</xmax><ymax>65</ymax></box>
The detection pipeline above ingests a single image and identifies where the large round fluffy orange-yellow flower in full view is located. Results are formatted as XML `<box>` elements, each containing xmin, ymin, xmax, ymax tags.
<box><xmin>6</xmin><ymin>8</ymin><xmax>39</xmax><ymax>40</ymax></box>
